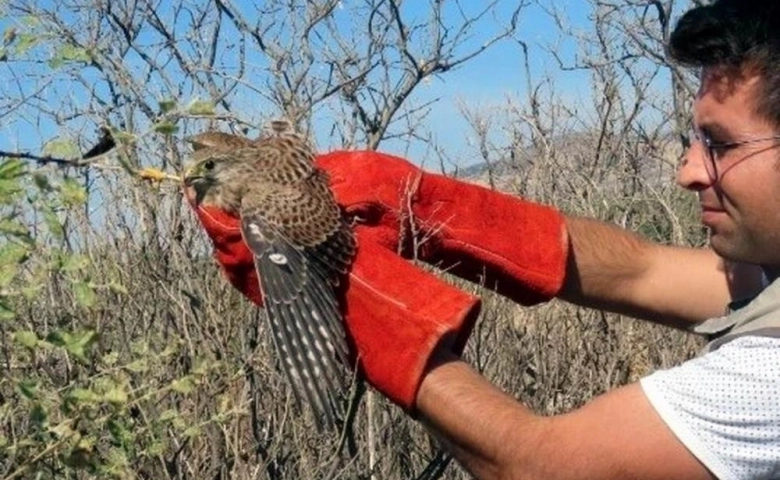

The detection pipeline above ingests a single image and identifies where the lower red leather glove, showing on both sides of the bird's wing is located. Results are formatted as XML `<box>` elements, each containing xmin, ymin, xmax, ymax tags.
<box><xmin>189</xmin><ymin>202</ymin><xmax>480</xmax><ymax>410</ymax></box>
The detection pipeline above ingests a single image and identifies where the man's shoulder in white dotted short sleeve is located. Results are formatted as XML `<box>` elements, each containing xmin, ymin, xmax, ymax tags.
<box><xmin>641</xmin><ymin>335</ymin><xmax>780</xmax><ymax>478</ymax></box>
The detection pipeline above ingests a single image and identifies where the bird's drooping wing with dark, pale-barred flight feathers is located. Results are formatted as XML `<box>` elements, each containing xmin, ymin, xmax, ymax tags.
<box><xmin>241</xmin><ymin>199</ymin><xmax>349</xmax><ymax>425</ymax></box>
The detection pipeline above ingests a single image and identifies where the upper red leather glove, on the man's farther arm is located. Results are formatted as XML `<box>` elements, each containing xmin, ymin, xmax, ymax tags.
<box><xmin>317</xmin><ymin>151</ymin><xmax>568</xmax><ymax>305</ymax></box>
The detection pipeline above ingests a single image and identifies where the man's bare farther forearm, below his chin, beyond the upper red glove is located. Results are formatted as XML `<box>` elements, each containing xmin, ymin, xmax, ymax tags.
<box><xmin>559</xmin><ymin>217</ymin><xmax>761</xmax><ymax>328</ymax></box>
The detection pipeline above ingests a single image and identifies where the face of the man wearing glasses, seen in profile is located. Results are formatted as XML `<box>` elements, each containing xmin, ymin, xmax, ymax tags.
<box><xmin>677</xmin><ymin>70</ymin><xmax>780</xmax><ymax>272</ymax></box>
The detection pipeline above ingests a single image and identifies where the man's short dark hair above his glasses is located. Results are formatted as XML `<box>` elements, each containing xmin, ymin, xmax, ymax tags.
<box><xmin>667</xmin><ymin>0</ymin><xmax>780</xmax><ymax>126</ymax></box>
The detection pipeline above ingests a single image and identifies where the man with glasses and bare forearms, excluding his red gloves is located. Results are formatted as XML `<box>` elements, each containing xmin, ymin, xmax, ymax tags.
<box><xmin>408</xmin><ymin>0</ymin><xmax>780</xmax><ymax>479</ymax></box>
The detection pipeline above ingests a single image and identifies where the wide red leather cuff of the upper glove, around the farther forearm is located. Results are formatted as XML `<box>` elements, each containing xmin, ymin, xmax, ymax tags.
<box><xmin>413</xmin><ymin>173</ymin><xmax>569</xmax><ymax>305</ymax></box>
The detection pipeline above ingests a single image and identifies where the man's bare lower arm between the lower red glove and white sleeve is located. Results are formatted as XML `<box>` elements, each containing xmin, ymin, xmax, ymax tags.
<box><xmin>417</xmin><ymin>351</ymin><xmax>714</xmax><ymax>480</ymax></box>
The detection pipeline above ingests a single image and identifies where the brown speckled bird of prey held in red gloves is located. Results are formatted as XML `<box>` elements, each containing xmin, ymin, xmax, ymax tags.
<box><xmin>183</xmin><ymin>121</ymin><xmax>356</xmax><ymax>425</ymax></box>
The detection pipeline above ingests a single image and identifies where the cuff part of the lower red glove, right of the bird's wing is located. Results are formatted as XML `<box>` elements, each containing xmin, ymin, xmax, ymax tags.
<box><xmin>345</xmin><ymin>234</ymin><xmax>480</xmax><ymax>409</ymax></box>
